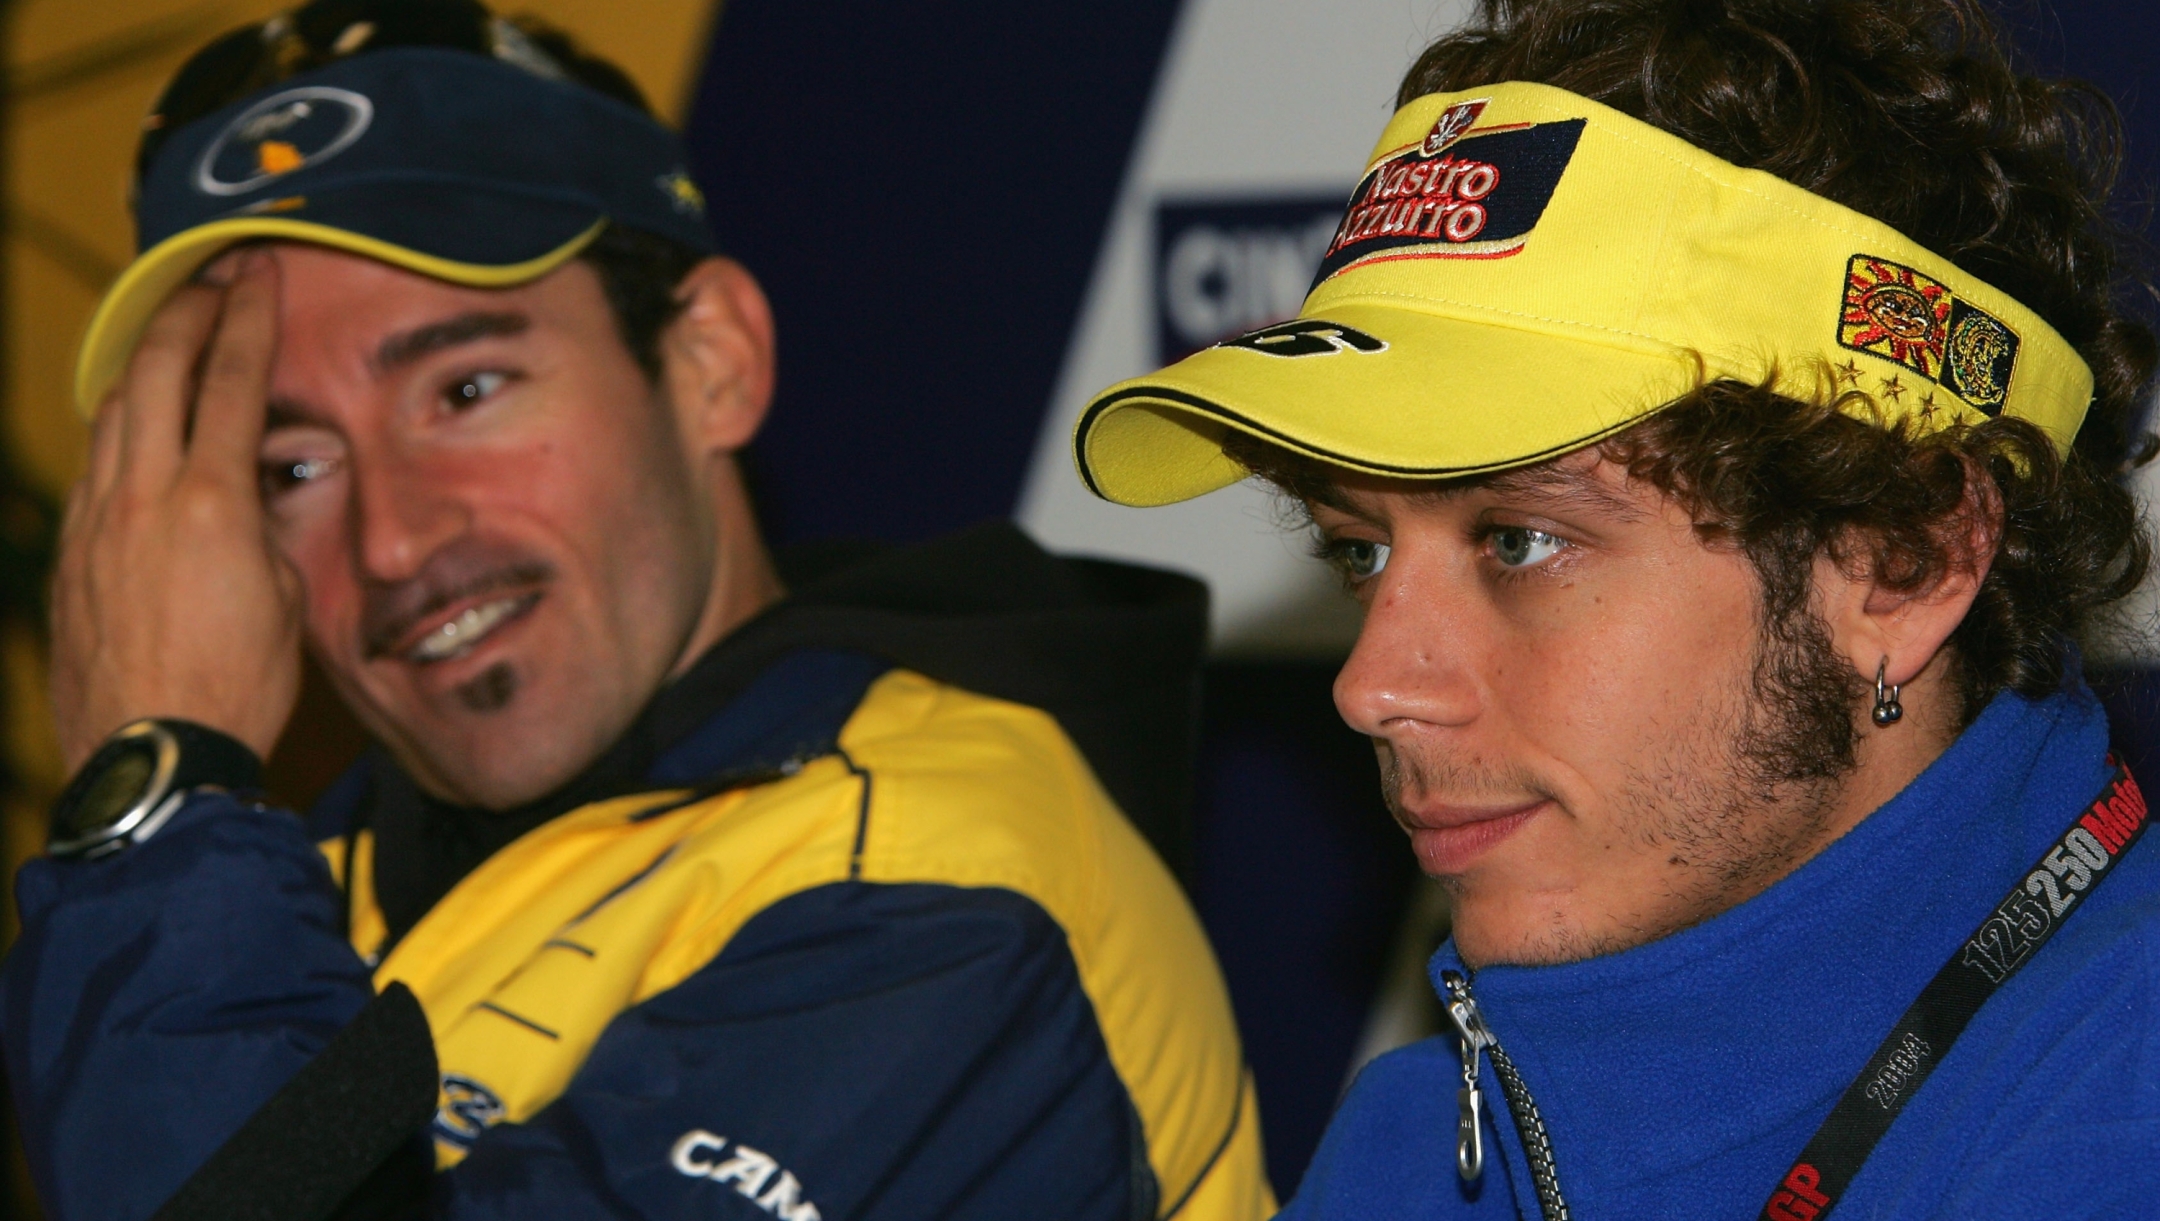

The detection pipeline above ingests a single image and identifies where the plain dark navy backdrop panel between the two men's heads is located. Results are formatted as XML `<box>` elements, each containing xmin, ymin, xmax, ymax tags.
<box><xmin>689</xmin><ymin>0</ymin><xmax>1177</xmax><ymax>540</ymax></box>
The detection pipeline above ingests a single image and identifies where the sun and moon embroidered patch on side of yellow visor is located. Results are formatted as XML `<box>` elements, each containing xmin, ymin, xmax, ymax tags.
<box><xmin>1838</xmin><ymin>255</ymin><xmax>2017</xmax><ymax>415</ymax></box>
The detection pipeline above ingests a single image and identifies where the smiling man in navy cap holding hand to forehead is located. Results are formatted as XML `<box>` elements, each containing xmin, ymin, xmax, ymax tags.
<box><xmin>0</xmin><ymin>0</ymin><xmax>1272</xmax><ymax>1221</ymax></box>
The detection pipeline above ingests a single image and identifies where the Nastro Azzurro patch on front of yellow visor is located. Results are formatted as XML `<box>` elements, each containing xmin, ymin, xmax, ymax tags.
<box><xmin>1313</xmin><ymin>115</ymin><xmax>1583</xmax><ymax>287</ymax></box>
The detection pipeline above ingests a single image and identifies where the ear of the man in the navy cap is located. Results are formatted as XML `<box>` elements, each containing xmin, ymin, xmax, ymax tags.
<box><xmin>661</xmin><ymin>257</ymin><xmax>773</xmax><ymax>454</ymax></box>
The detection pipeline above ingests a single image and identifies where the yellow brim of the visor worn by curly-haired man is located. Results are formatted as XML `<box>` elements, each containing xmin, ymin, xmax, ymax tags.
<box><xmin>1078</xmin><ymin>303</ymin><xmax>1700</xmax><ymax>506</ymax></box>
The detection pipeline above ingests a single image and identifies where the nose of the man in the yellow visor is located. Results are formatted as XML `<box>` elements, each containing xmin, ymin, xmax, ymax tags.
<box><xmin>1335</xmin><ymin>549</ymin><xmax>1482</xmax><ymax>737</ymax></box>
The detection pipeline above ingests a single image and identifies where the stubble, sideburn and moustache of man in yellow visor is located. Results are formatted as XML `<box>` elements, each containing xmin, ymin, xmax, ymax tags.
<box><xmin>1380</xmin><ymin>607</ymin><xmax>1864</xmax><ymax>964</ymax></box>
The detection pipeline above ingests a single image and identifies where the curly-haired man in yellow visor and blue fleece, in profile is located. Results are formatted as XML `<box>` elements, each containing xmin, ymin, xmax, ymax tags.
<box><xmin>1076</xmin><ymin>0</ymin><xmax>2160</xmax><ymax>1221</ymax></box>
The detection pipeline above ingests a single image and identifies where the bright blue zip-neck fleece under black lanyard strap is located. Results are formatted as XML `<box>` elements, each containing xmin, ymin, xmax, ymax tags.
<box><xmin>1283</xmin><ymin>689</ymin><xmax>2160</xmax><ymax>1221</ymax></box>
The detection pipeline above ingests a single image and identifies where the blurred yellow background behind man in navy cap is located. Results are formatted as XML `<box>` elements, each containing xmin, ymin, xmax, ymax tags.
<box><xmin>0</xmin><ymin>0</ymin><xmax>717</xmax><ymax>1215</ymax></box>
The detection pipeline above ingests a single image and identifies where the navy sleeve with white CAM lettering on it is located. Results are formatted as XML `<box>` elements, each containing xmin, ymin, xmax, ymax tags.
<box><xmin>434</xmin><ymin>882</ymin><xmax>1156</xmax><ymax>1221</ymax></box>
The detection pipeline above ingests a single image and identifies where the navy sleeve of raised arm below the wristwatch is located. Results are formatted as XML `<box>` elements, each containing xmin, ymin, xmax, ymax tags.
<box><xmin>0</xmin><ymin>793</ymin><xmax>374</xmax><ymax>1219</ymax></box>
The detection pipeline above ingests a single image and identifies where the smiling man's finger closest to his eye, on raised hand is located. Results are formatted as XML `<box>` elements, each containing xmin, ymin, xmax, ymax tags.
<box><xmin>188</xmin><ymin>251</ymin><xmax>279</xmax><ymax>488</ymax></box>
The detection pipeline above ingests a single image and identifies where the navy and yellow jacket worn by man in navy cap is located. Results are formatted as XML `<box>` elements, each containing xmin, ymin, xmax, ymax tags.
<box><xmin>0</xmin><ymin>522</ymin><xmax>1272</xmax><ymax>1221</ymax></box>
